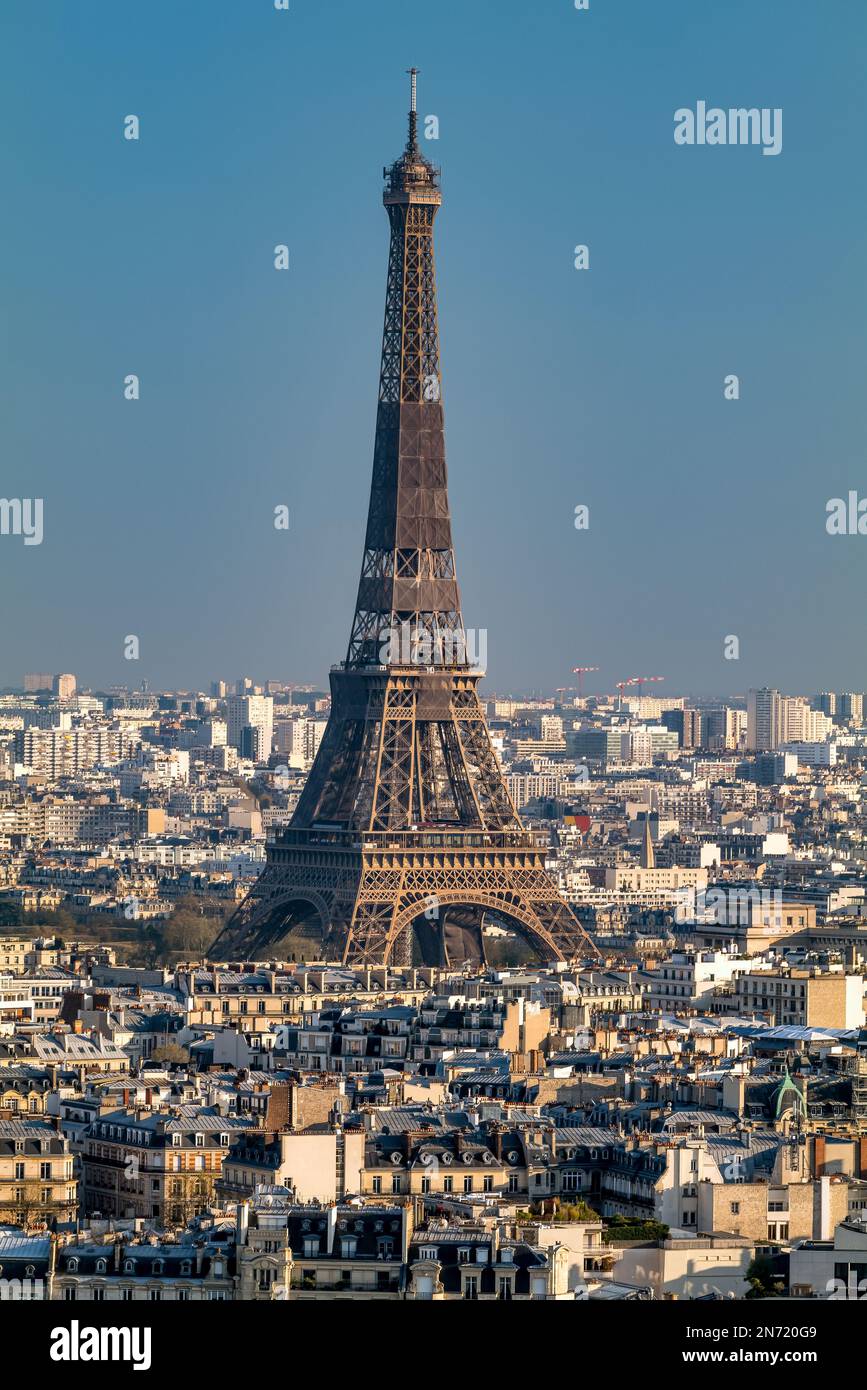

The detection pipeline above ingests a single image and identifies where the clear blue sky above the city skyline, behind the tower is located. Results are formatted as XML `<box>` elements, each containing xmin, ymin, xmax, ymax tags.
<box><xmin>0</xmin><ymin>0</ymin><xmax>867</xmax><ymax>694</ymax></box>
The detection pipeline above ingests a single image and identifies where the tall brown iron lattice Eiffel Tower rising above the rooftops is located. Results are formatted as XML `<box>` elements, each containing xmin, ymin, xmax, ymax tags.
<box><xmin>210</xmin><ymin>68</ymin><xmax>599</xmax><ymax>965</ymax></box>
